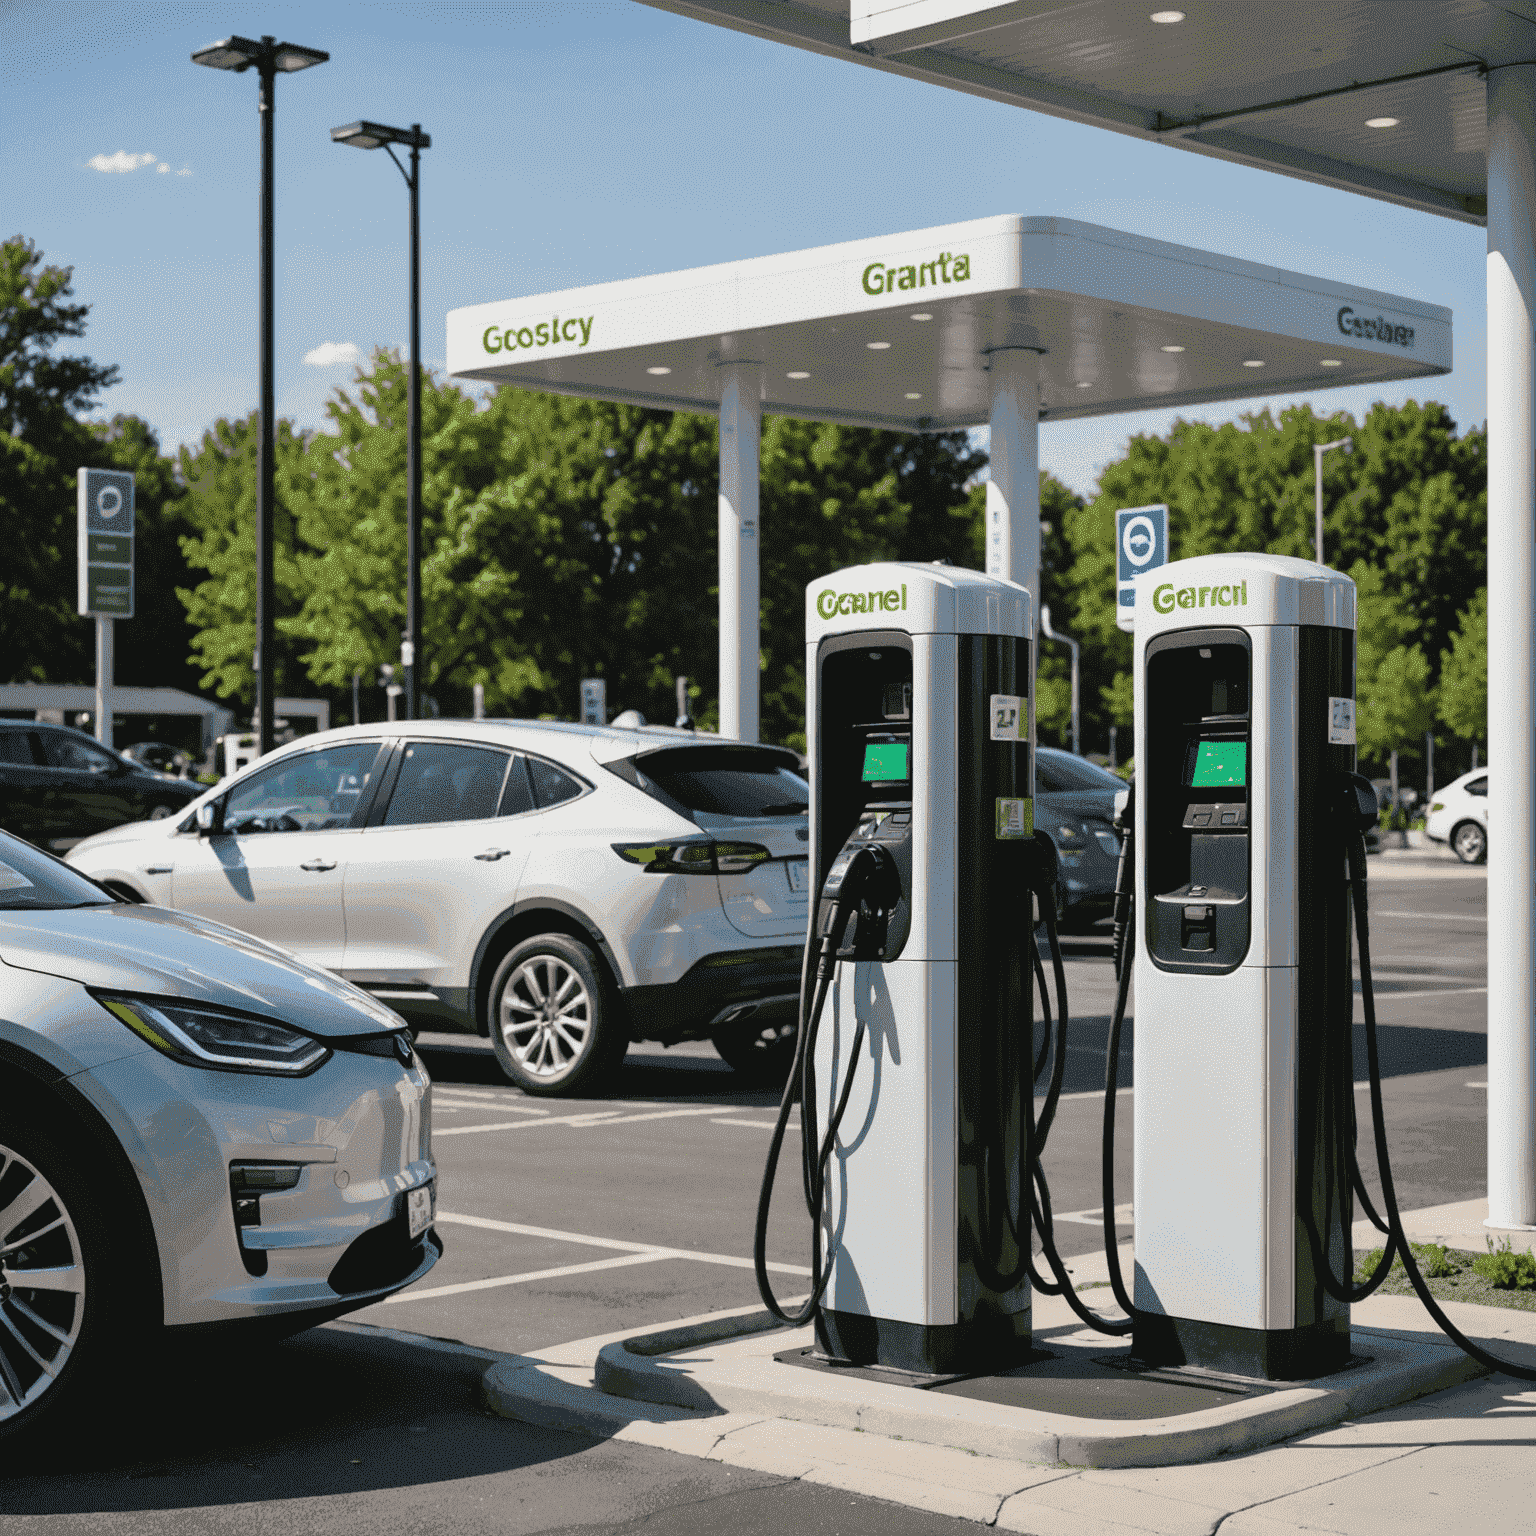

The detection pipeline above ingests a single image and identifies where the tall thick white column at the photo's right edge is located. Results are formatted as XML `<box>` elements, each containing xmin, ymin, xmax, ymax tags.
<box><xmin>1488</xmin><ymin>65</ymin><xmax>1536</xmax><ymax>1227</ymax></box>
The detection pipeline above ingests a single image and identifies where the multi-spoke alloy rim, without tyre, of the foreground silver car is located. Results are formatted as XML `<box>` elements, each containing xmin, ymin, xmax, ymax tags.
<box><xmin>0</xmin><ymin>1144</ymin><xmax>86</xmax><ymax>1422</ymax></box>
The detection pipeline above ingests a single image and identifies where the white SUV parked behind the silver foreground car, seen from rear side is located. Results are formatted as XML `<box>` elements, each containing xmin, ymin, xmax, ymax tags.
<box><xmin>69</xmin><ymin>720</ymin><xmax>808</xmax><ymax>1094</ymax></box>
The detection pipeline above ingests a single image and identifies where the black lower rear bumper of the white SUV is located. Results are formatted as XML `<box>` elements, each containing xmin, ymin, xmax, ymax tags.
<box><xmin>624</xmin><ymin>945</ymin><xmax>805</xmax><ymax>1044</ymax></box>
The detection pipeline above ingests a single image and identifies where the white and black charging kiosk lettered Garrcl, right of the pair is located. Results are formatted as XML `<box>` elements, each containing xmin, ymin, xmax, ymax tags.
<box><xmin>1134</xmin><ymin>554</ymin><xmax>1355</xmax><ymax>1379</ymax></box>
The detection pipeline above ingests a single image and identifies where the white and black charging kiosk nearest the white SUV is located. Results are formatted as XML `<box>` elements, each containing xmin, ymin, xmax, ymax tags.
<box><xmin>805</xmin><ymin>564</ymin><xmax>1034</xmax><ymax>1375</ymax></box>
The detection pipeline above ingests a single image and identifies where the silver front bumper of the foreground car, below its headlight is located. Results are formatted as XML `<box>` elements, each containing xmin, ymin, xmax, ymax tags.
<box><xmin>75</xmin><ymin>1049</ymin><xmax>441</xmax><ymax>1326</ymax></box>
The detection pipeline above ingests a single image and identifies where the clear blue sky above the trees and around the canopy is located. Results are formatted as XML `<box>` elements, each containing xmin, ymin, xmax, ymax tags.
<box><xmin>0</xmin><ymin>0</ymin><xmax>1485</xmax><ymax>495</ymax></box>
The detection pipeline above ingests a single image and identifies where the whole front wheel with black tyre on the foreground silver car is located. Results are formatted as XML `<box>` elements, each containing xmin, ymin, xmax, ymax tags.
<box><xmin>0</xmin><ymin>1117</ymin><xmax>139</xmax><ymax>1442</ymax></box>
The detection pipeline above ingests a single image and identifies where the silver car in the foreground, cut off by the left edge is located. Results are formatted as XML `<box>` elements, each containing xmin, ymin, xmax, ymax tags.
<box><xmin>0</xmin><ymin>833</ymin><xmax>441</xmax><ymax>1441</ymax></box>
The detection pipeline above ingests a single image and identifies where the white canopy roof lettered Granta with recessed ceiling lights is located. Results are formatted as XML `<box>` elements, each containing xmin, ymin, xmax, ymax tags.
<box><xmin>447</xmin><ymin>214</ymin><xmax>1452</xmax><ymax>432</ymax></box>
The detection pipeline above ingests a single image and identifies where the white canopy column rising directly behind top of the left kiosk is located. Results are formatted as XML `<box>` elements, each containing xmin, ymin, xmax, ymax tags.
<box><xmin>986</xmin><ymin>347</ymin><xmax>1040</xmax><ymax>614</ymax></box>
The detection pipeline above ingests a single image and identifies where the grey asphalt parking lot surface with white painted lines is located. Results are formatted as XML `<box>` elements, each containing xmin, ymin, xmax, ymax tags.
<box><xmin>0</xmin><ymin>860</ymin><xmax>1485</xmax><ymax>1536</ymax></box>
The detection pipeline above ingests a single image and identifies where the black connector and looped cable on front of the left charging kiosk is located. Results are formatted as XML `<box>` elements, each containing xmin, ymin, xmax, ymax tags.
<box><xmin>753</xmin><ymin>843</ymin><xmax>902</xmax><ymax>1327</ymax></box>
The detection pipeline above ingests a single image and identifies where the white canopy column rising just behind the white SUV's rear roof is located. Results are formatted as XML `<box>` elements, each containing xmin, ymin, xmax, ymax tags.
<box><xmin>717</xmin><ymin>362</ymin><xmax>762</xmax><ymax>742</ymax></box>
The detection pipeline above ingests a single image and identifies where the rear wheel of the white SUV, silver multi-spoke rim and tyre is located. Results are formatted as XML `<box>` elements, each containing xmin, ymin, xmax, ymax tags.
<box><xmin>488</xmin><ymin>934</ymin><xmax>628</xmax><ymax>1097</ymax></box>
